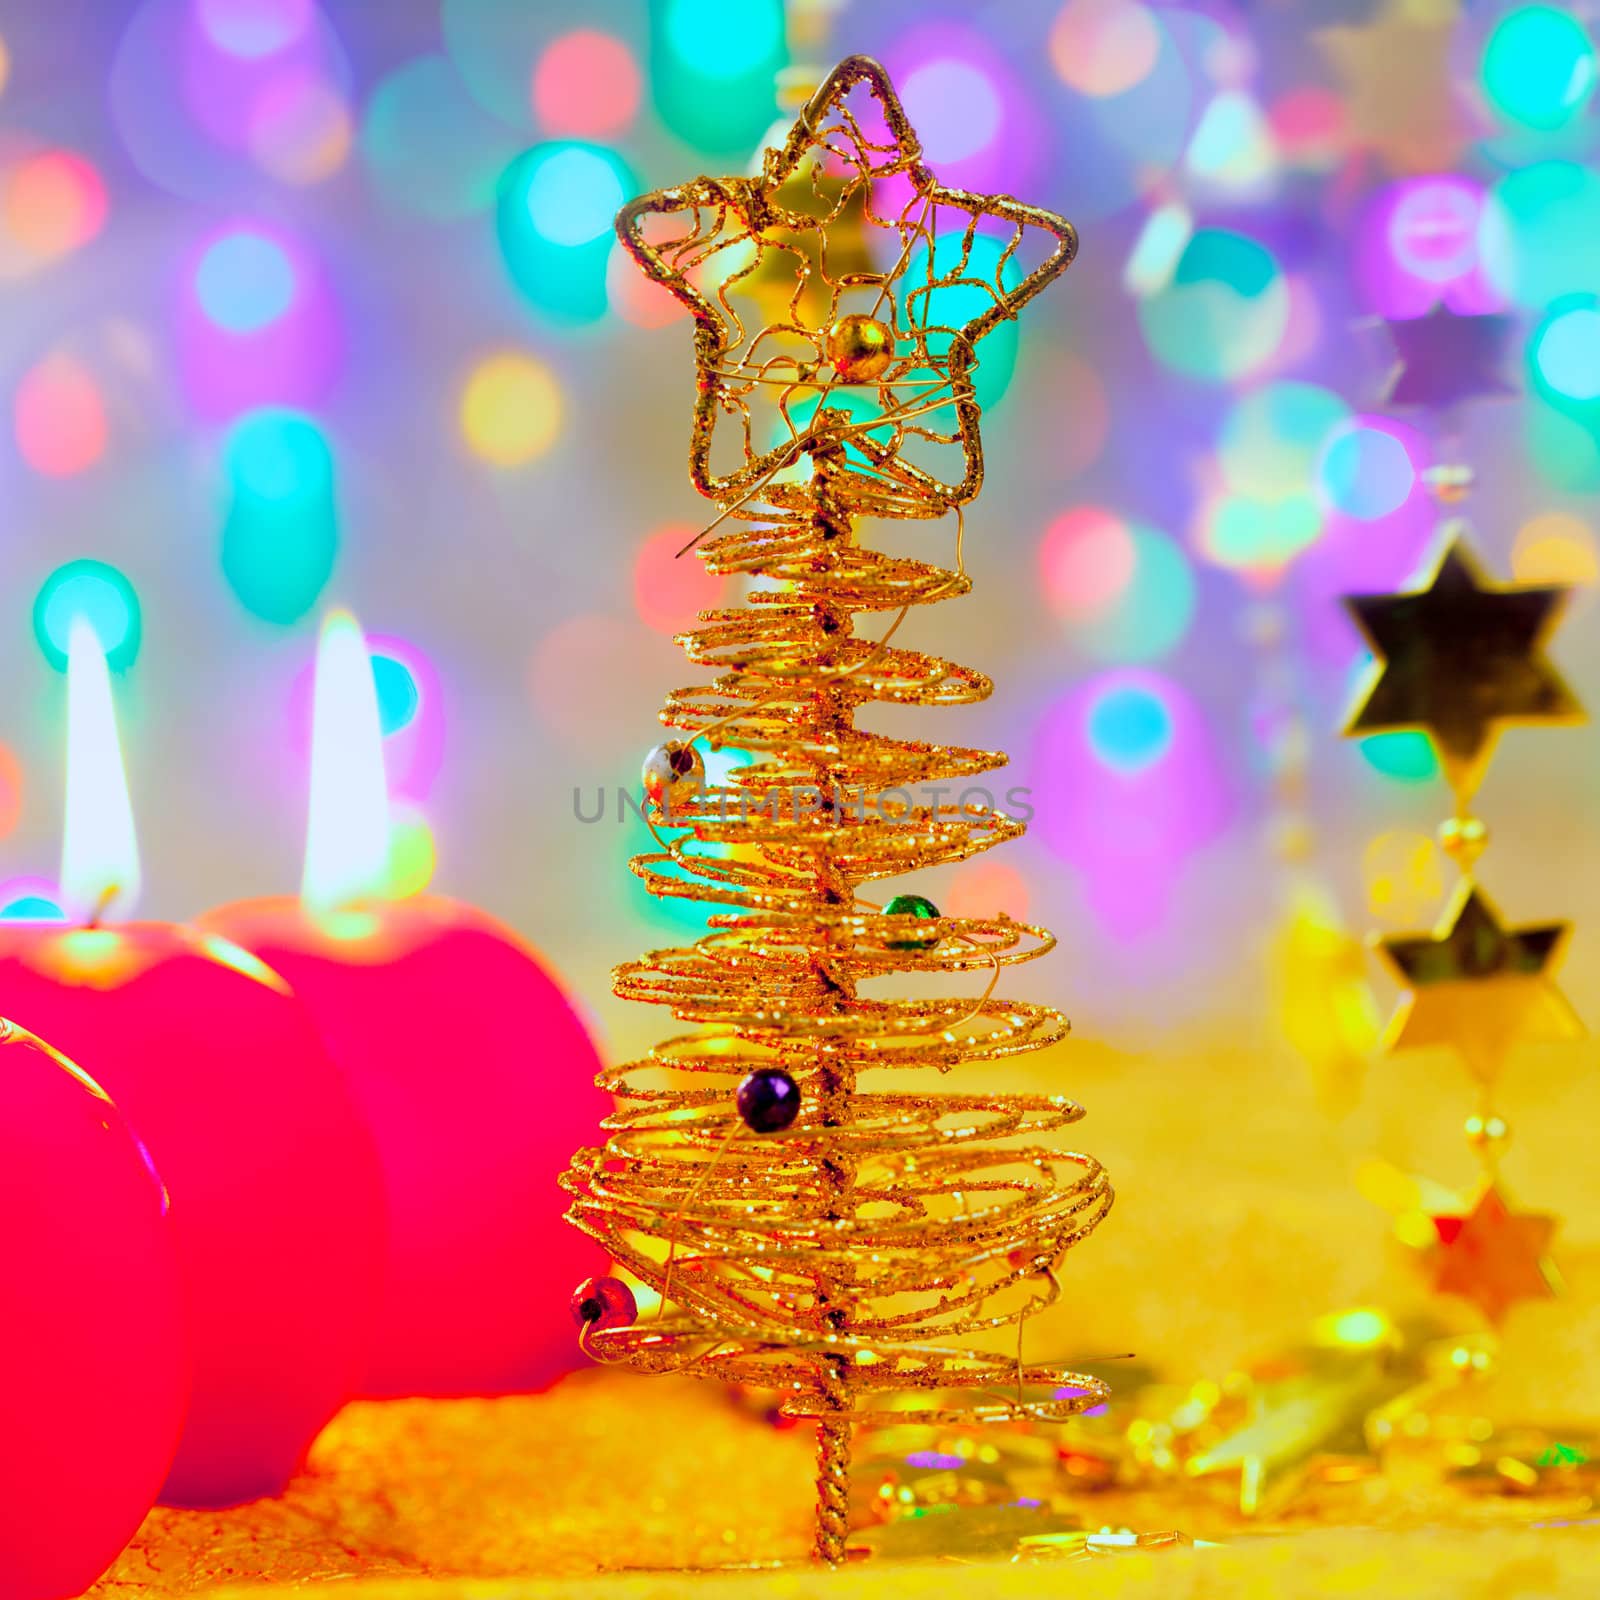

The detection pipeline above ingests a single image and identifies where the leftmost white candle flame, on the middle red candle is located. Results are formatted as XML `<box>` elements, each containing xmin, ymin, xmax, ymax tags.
<box><xmin>61</xmin><ymin>616</ymin><xmax>142</xmax><ymax>923</ymax></box>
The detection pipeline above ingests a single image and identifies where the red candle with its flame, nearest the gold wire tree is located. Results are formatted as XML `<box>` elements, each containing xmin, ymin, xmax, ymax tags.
<box><xmin>205</xmin><ymin>613</ymin><xmax>610</xmax><ymax>1395</ymax></box>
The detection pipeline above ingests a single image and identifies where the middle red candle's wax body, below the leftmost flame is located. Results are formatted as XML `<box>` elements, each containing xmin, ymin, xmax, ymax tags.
<box><xmin>0</xmin><ymin>923</ymin><xmax>384</xmax><ymax>1517</ymax></box>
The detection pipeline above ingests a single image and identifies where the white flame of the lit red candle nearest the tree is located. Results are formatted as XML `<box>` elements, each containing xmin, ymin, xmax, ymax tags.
<box><xmin>301</xmin><ymin>611</ymin><xmax>389</xmax><ymax>914</ymax></box>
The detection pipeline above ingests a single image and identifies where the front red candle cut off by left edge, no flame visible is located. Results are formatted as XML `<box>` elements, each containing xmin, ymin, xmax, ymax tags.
<box><xmin>0</xmin><ymin>1021</ymin><xmax>189</xmax><ymax>1600</ymax></box>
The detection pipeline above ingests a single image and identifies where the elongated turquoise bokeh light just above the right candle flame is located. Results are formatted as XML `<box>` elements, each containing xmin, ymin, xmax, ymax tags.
<box><xmin>222</xmin><ymin>410</ymin><xmax>339</xmax><ymax>622</ymax></box>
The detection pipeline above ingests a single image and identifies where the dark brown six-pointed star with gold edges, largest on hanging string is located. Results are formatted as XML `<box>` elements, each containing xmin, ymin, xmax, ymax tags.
<box><xmin>1344</xmin><ymin>525</ymin><xmax>1584</xmax><ymax>800</ymax></box>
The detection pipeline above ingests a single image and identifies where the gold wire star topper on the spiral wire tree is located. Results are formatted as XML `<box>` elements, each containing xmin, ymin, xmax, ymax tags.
<box><xmin>618</xmin><ymin>56</ymin><xmax>1077</xmax><ymax>517</ymax></box>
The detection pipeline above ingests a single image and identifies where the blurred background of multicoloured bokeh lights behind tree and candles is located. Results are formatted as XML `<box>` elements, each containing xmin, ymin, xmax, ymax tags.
<box><xmin>9</xmin><ymin>0</ymin><xmax>1600</xmax><ymax>1376</ymax></box>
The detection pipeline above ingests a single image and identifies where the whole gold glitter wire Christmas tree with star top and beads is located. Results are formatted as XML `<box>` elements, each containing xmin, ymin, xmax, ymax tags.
<box><xmin>565</xmin><ymin>56</ymin><xmax>1112</xmax><ymax>1562</ymax></box>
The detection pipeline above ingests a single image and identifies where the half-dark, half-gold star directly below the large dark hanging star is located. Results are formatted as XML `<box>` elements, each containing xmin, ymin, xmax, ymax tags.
<box><xmin>1378</xmin><ymin>878</ymin><xmax>1584</xmax><ymax>1082</ymax></box>
